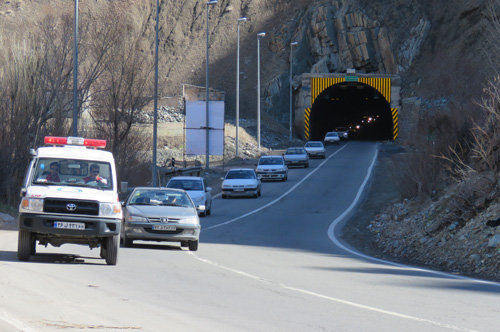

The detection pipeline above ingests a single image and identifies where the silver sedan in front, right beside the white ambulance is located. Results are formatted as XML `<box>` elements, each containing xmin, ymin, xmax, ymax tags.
<box><xmin>120</xmin><ymin>187</ymin><xmax>200</xmax><ymax>251</ymax></box>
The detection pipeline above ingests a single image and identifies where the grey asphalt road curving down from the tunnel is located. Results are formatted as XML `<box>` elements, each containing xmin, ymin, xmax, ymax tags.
<box><xmin>0</xmin><ymin>142</ymin><xmax>500</xmax><ymax>331</ymax></box>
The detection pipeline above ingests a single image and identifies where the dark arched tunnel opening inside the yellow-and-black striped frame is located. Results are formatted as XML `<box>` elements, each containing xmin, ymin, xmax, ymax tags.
<box><xmin>309</xmin><ymin>82</ymin><xmax>393</xmax><ymax>140</ymax></box>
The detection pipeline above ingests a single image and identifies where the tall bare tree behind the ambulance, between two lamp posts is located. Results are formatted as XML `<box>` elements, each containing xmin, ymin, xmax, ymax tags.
<box><xmin>90</xmin><ymin>3</ymin><xmax>153</xmax><ymax>177</ymax></box>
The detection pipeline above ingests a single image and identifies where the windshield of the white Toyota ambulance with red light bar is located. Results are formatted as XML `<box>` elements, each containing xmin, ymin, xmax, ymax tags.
<box><xmin>32</xmin><ymin>158</ymin><xmax>113</xmax><ymax>189</ymax></box>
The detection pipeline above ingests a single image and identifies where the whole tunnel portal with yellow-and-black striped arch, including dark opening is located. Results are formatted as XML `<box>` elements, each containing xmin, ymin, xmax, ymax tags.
<box><xmin>296</xmin><ymin>74</ymin><xmax>399</xmax><ymax>141</ymax></box>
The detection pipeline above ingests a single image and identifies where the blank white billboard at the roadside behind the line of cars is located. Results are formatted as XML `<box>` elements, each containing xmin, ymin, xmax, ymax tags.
<box><xmin>186</xmin><ymin>100</ymin><xmax>224</xmax><ymax>156</ymax></box>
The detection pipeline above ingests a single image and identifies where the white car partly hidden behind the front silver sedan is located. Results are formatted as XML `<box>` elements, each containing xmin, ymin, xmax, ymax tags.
<box><xmin>167</xmin><ymin>176</ymin><xmax>212</xmax><ymax>217</ymax></box>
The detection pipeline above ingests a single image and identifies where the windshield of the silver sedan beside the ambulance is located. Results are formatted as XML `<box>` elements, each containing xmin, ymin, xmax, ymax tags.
<box><xmin>128</xmin><ymin>188</ymin><xmax>194</xmax><ymax>207</ymax></box>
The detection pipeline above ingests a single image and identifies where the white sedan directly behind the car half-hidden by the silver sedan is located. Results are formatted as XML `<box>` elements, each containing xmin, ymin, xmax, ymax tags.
<box><xmin>222</xmin><ymin>168</ymin><xmax>261</xmax><ymax>198</ymax></box>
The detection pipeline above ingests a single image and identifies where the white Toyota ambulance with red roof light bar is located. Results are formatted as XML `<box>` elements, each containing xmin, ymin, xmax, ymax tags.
<box><xmin>17</xmin><ymin>137</ymin><xmax>122</xmax><ymax>265</ymax></box>
